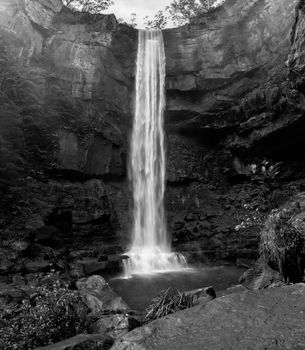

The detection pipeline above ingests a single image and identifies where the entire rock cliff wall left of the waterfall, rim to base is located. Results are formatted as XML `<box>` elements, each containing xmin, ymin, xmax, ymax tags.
<box><xmin>0</xmin><ymin>0</ymin><xmax>137</xmax><ymax>253</ymax></box>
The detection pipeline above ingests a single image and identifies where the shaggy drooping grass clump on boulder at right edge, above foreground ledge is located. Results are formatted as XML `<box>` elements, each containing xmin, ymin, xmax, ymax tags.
<box><xmin>260</xmin><ymin>208</ymin><xmax>305</xmax><ymax>283</ymax></box>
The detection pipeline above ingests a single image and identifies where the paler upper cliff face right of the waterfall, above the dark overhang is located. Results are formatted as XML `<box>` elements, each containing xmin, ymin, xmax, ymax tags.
<box><xmin>164</xmin><ymin>0</ymin><xmax>296</xmax><ymax>119</ymax></box>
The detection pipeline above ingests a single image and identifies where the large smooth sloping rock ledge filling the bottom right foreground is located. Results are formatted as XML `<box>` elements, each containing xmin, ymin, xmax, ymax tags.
<box><xmin>111</xmin><ymin>284</ymin><xmax>305</xmax><ymax>350</ymax></box>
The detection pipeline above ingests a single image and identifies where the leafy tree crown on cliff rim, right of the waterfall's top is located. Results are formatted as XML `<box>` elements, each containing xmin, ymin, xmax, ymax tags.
<box><xmin>166</xmin><ymin>0</ymin><xmax>217</xmax><ymax>26</ymax></box>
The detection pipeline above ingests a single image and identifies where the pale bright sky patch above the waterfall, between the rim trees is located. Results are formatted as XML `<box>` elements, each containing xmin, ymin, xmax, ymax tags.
<box><xmin>105</xmin><ymin>0</ymin><xmax>171</xmax><ymax>28</ymax></box>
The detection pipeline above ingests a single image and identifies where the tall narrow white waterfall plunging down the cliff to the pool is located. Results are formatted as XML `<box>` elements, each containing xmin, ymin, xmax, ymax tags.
<box><xmin>125</xmin><ymin>29</ymin><xmax>186</xmax><ymax>276</ymax></box>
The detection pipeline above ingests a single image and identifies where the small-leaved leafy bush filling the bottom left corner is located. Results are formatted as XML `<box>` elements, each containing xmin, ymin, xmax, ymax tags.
<box><xmin>0</xmin><ymin>274</ymin><xmax>86</xmax><ymax>350</ymax></box>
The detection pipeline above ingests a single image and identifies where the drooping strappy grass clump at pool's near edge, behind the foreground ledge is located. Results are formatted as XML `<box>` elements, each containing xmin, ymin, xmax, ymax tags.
<box><xmin>144</xmin><ymin>288</ymin><xmax>194</xmax><ymax>323</ymax></box>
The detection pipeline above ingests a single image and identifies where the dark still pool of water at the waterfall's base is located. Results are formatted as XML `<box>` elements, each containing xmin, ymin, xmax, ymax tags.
<box><xmin>107</xmin><ymin>266</ymin><xmax>245</xmax><ymax>311</ymax></box>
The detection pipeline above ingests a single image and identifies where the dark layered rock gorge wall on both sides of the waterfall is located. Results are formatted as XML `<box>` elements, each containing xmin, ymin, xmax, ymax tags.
<box><xmin>0</xmin><ymin>0</ymin><xmax>305</xmax><ymax>270</ymax></box>
